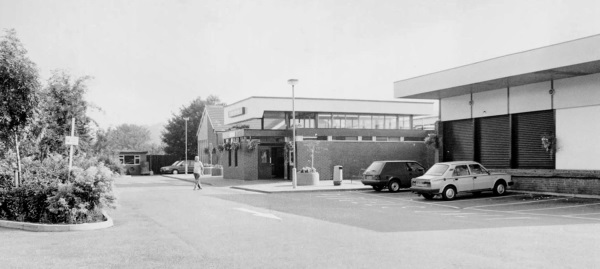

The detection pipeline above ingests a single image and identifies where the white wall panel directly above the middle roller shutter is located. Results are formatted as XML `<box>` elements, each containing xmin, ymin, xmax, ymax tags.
<box><xmin>473</xmin><ymin>89</ymin><xmax>508</xmax><ymax>118</ymax></box>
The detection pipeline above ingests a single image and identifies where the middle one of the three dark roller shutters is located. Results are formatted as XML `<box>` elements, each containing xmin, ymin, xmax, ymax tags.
<box><xmin>475</xmin><ymin>115</ymin><xmax>510</xmax><ymax>168</ymax></box>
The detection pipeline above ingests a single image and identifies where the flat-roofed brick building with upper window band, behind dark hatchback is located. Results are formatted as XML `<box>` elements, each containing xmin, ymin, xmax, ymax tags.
<box><xmin>198</xmin><ymin>97</ymin><xmax>437</xmax><ymax>180</ymax></box>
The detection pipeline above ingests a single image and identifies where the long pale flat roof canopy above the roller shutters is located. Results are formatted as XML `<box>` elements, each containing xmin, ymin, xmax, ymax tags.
<box><xmin>394</xmin><ymin>35</ymin><xmax>600</xmax><ymax>99</ymax></box>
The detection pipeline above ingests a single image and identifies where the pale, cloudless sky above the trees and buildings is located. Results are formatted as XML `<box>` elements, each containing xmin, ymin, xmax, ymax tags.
<box><xmin>0</xmin><ymin>0</ymin><xmax>600</xmax><ymax>128</ymax></box>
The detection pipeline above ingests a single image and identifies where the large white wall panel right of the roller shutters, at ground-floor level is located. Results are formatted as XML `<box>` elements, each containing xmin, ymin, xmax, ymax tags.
<box><xmin>556</xmin><ymin>105</ymin><xmax>600</xmax><ymax>170</ymax></box>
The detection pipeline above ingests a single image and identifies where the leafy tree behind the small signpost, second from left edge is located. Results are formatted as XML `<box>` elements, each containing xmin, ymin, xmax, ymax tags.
<box><xmin>37</xmin><ymin>70</ymin><xmax>93</xmax><ymax>158</ymax></box>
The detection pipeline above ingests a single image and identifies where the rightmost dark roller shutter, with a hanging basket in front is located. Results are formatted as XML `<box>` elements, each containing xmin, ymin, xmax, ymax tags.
<box><xmin>513</xmin><ymin>110</ymin><xmax>555</xmax><ymax>169</ymax></box>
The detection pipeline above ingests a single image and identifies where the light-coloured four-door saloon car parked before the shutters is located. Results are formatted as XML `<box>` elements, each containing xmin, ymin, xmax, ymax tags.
<box><xmin>410</xmin><ymin>161</ymin><xmax>514</xmax><ymax>200</ymax></box>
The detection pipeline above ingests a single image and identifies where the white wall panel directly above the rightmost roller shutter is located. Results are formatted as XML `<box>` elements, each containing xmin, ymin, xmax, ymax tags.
<box><xmin>509</xmin><ymin>81</ymin><xmax>552</xmax><ymax>114</ymax></box>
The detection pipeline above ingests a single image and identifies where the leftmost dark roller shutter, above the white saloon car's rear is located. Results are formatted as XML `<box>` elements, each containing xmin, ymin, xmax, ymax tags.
<box><xmin>443</xmin><ymin>119</ymin><xmax>473</xmax><ymax>162</ymax></box>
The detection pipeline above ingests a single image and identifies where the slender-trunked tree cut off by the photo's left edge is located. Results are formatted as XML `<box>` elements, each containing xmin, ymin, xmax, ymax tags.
<box><xmin>0</xmin><ymin>30</ymin><xmax>39</xmax><ymax>181</ymax></box>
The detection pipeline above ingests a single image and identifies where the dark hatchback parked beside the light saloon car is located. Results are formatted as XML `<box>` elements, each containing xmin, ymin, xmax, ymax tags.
<box><xmin>361</xmin><ymin>160</ymin><xmax>425</xmax><ymax>192</ymax></box>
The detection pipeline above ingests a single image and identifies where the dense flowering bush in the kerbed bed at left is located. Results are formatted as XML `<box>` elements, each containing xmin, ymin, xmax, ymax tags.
<box><xmin>0</xmin><ymin>155</ymin><xmax>117</xmax><ymax>223</ymax></box>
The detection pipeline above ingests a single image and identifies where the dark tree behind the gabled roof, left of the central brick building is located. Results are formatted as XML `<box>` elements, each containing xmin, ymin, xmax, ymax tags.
<box><xmin>162</xmin><ymin>95</ymin><xmax>221</xmax><ymax>159</ymax></box>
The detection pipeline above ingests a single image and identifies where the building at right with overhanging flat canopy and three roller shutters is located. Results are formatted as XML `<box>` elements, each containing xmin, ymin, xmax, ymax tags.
<box><xmin>394</xmin><ymin>35</ymin><xmax>600</xmax><ymax>194</ymax></box>
